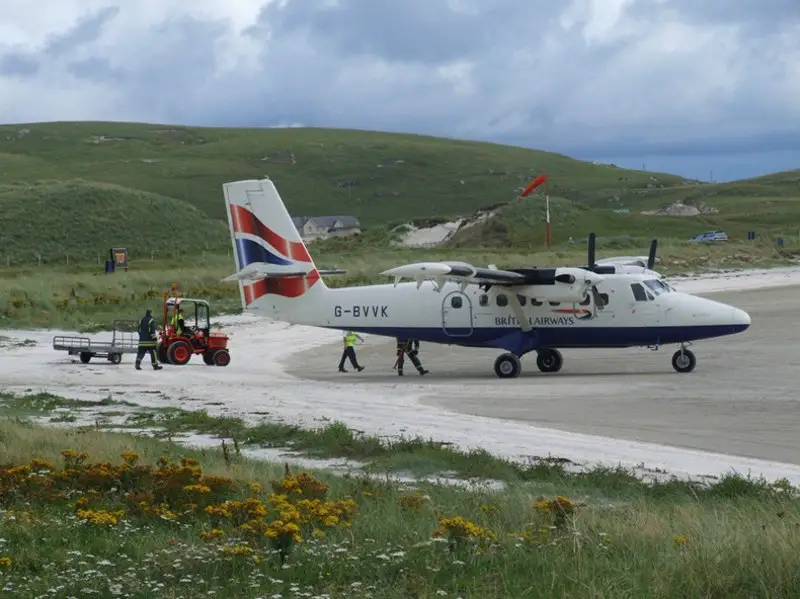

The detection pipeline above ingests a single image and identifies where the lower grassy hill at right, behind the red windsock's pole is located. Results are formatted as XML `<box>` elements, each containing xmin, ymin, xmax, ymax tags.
<box><xmin>449</xmin><ymin>170</ymin><xmax>800</xmax><ymax>252</ymax></box>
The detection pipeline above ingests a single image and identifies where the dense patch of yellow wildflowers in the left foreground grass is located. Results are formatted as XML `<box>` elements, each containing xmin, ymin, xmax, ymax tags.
<box><xmin>0</xmin><ymin>449</ymin><xmax>356</xmax><ymax>565</ymax></box>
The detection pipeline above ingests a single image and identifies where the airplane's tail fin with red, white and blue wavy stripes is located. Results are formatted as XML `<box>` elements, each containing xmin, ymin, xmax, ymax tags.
<box><xmin>223</xmin><ymin>179</ymin><xmax>326</xmax><ymax>311</ymax></box>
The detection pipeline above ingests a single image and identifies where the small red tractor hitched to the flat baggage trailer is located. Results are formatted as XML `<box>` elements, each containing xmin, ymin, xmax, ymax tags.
<box><xmin>156</xmin><ymin>285</ymin><xmax>231</xmax><ymax>366</ymax></box>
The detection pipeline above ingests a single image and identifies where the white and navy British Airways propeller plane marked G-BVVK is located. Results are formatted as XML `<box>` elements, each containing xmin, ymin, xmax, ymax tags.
<box><xmin>223</xmin><ymin>179</ymin><xmax>750</xmax><ymax>378</ymax></box>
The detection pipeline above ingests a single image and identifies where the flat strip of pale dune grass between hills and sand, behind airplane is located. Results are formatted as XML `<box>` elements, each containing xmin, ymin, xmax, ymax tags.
<box><xmin>0</xmin><ymin>236</ymin><xmax>789</xmax><ymax>332</ymax></box>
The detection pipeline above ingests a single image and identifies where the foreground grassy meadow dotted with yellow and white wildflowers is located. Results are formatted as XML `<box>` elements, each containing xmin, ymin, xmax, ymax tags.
<box><xmin>0</xmin><ymin>421</ymin><xmax>800</xmax><ymax>598</ymax></box>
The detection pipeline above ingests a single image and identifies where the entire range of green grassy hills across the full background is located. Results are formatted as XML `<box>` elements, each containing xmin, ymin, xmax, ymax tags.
<box><xmin>0</xmin><ymin>122</ymin><xmax>800</xmax><ymax>264</ymax></box>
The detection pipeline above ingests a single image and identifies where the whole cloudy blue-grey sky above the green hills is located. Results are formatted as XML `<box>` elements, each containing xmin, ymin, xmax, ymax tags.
<box><xmin>0</xmin><ymin>0</ymin><xmax>800</xmax><ymax>180</ymax></box>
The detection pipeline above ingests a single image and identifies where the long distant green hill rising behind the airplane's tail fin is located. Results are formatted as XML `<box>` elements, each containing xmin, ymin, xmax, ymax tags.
<box><xmin>0</xmin><ymin>123</ymin><xmax>684</xmax><ymax>226</ymax></box>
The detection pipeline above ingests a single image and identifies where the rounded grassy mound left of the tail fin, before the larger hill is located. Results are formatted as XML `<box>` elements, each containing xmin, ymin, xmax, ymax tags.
<box><xmin>0</xmin><ymin>181</ymin><xmax>230</xmax><ymax>266</ymax></box>
